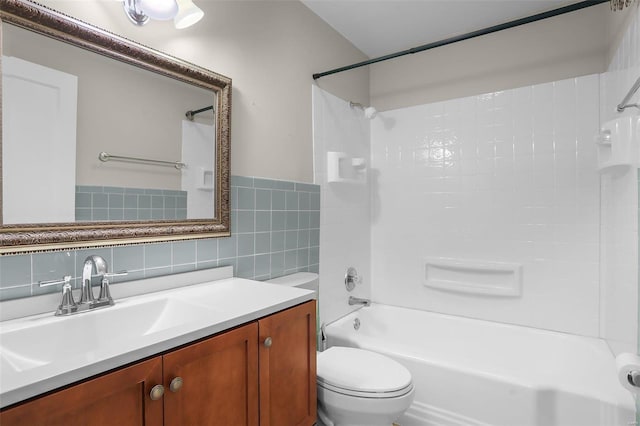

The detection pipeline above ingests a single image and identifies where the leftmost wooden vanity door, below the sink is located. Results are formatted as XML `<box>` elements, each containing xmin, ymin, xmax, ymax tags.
<box><xmin>0</xmin><ymin>357</ymin><xmax>163</xmax><ymax>426</ymax></box>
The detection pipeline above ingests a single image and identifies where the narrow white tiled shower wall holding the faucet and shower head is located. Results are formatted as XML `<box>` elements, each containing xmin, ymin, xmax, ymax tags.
<box><xmin>312</xmin><ymin>86</ymin><xmax>375</xmax><ymax>323</ymax></box>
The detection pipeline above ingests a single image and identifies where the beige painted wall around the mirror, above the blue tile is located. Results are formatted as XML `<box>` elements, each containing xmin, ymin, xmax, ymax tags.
<box><xmin>45</xmin><ymin>0</ymin><xmax>369</xmax><ymax>182</ymax></box>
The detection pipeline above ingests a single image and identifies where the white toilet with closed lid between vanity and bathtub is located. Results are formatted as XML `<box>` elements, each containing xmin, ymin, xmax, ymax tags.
<box><xmin>267</xmin><ymin>272</ymin><xmax>414</xmax><ymax>426</ymax></box>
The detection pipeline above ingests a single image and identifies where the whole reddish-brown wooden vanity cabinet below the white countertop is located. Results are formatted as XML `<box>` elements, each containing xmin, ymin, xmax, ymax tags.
<box><xmin>0</xmin><ymin>301</ymin><xmax>316</xmax><ymax>426</ymax></box>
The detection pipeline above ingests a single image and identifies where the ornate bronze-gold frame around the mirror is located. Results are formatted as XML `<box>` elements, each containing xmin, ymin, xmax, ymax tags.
<box><xmin>0</xmin><ymin>0</ymin><xmax>231</xmax><ymax>254</ymax></box>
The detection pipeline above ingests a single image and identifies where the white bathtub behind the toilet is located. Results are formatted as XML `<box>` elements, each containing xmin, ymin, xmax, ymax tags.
<box><xmin>326</xmin><ymin>303</ymin><xmax>635</xmax><ymax>426</ymax></box>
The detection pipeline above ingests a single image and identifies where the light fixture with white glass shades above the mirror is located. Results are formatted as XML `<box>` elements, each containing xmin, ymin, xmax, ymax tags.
<box><xmin>123</xmin><ymin>0</ymin><xmax>204</xmax><ymax>29</ymax></box>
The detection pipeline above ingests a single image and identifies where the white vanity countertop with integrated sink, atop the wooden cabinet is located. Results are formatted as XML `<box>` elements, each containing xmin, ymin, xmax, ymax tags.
<box><xmin>0</xmin><ymin>274</ymin><xmax>314</xmax><ymax>407</ymax></box>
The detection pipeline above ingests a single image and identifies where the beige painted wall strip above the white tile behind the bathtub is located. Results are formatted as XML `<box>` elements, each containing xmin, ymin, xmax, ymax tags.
<box><xmin>370</xmin><ymin>4</ymin><xmax>617</xmax><ymax>111</ymax></box>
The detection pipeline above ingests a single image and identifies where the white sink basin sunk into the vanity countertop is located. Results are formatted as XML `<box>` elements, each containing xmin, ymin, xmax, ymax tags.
<box><xmin>0</xmin><ymin>297</ymin><xmax>214</xmax><ymax>373</ymax></box>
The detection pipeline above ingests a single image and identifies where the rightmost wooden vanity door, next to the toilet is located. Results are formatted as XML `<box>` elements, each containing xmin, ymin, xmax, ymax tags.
<box><xmin>258</xmin><ymin>301</ymin><xmax>317</xmax><ymax>426</ymax></box>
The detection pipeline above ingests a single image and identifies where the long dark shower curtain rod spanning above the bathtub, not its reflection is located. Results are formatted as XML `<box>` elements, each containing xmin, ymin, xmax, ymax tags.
<box><xmin>313</xmin><ymin>0</ymin><xmax>610</xmax><ymax>80</ymax></box>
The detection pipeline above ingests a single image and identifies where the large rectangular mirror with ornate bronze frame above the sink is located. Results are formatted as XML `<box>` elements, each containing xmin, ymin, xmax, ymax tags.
<box><xmin>0</xmin><ymin>0</ymin><xmax>231</xmax><ymax>254</ymax></box>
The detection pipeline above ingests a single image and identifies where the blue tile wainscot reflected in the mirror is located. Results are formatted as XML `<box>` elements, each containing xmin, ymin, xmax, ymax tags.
<box><xmin>76</xmin><ymin>185</ymin><xmax>187</xmax><ymax>222</ymax></box>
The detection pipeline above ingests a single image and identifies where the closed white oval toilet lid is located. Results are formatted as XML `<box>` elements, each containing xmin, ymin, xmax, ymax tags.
<box><xmin>317</xmin><ymin>346</ymin><xmax>411</xmax><ymax>393</ymax></box>
